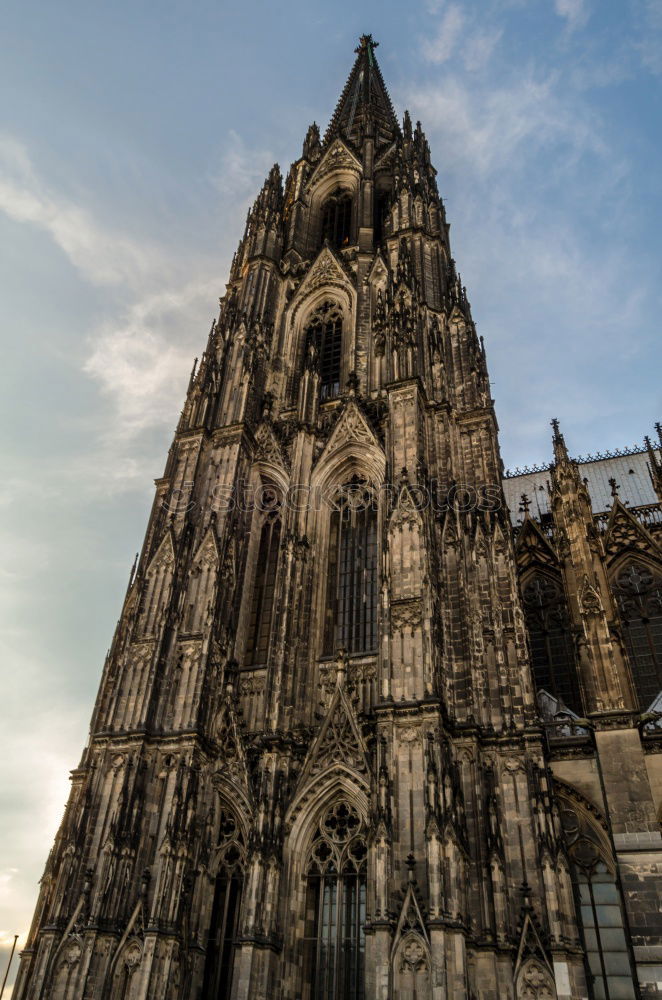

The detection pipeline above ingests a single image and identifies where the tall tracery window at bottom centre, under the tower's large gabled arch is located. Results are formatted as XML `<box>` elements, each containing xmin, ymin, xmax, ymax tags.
<box><xmin>303</xmin><ymin>799</ymin><xmax>368</xmax><ymax>1000</ymax></box>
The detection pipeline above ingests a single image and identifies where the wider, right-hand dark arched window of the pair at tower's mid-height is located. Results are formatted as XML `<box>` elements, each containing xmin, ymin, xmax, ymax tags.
<box><xmin>323</xmin><ymin>478</ymin><xmax>378</xmax><ymax>656</ymax></box>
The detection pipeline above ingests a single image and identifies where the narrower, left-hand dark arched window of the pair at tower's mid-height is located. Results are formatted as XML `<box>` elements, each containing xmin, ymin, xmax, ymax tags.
<box><xmin>244</xmin><ymin>508</ymin><xmax>281</xmax><ymax>666</ymax></box>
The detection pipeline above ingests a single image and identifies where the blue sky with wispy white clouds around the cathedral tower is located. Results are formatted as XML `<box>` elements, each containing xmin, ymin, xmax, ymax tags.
<box><xmin>0</xmin><ymin>0</ymin><xmax>662</xmax><ymax>995</ymax></box>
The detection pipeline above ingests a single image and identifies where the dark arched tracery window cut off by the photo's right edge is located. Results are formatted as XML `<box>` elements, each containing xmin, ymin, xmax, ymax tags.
<box><xmin>614</xmin><ymin>562</ymin><xmax>662</xmax><ymax>710</ymax></box>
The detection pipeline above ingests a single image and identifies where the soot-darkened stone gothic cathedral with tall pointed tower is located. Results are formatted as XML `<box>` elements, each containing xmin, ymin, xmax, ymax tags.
<box><xmin>14</xmin><ymin>35</ymin><xmax>662</xmax><ymax>1000</ymax></box>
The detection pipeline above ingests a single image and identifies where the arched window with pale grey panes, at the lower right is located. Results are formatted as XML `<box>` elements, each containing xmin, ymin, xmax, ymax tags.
<box><xmin>561</xmin><ymin>807</ymin><xmax>636</xmax><ymax>1000</ymax></box>
